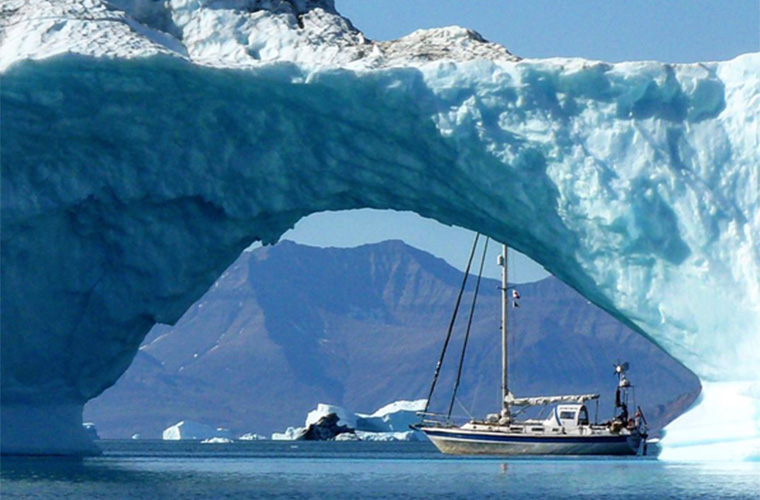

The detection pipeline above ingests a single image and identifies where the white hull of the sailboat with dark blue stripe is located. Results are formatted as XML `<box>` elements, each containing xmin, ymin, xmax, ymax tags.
<box><xmin>420</xmin><ymin>427</ymin><xmax>641</xmax><ymax>455</ymax></box>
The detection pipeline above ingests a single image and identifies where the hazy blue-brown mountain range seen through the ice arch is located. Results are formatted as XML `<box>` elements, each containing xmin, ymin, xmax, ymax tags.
<box><xmin>85</xmin><ymin>241</ymin><xmax>699</xmax><ymax>438</ymax></box>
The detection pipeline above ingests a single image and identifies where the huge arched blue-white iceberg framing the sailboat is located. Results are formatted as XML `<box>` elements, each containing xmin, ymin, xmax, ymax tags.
<box><xmin>0</xmin><ymin>0</ymin><xmax>760</xmax><ymax>459</ymax></box>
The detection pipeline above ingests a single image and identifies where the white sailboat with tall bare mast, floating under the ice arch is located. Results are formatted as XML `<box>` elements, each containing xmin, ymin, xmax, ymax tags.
<box><xmin>415</xmin><ymin>237</ymin><xmax>647</xmax><ymax>455</ymax></box>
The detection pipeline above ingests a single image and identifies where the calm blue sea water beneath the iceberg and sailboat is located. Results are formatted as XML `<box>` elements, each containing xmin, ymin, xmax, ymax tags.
<box><xmin>0</xmin><ymin>441</ymin><xmax>760</xmax><ymax>500</ymax></box>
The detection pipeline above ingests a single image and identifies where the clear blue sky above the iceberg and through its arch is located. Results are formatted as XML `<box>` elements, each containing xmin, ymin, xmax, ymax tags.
<box><xmin>283</xmin><ymin>0</ymin><xmax>760</xmax><ymax>283</ymax></box>
